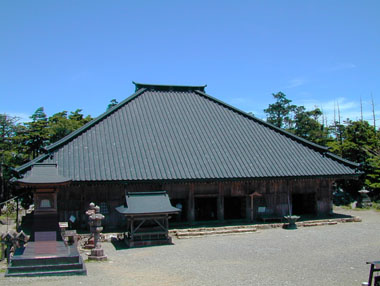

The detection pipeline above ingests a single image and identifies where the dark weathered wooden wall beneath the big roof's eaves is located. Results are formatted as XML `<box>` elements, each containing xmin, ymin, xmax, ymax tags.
<box><xmin>58</xmin><ymin>179</ymin><xmax>334</xmax><ymax>228</ymax></box>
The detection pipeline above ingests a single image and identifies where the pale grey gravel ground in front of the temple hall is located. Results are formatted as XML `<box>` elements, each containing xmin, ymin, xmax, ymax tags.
<box><xmin>0</xmin><ymin>209</ymin><xmax>380</xmax><ymax>286</ymax></box>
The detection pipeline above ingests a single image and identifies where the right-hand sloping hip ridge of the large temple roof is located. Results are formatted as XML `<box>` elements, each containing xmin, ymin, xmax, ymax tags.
<box><xmin>195</xmin><ymin>90</ymin><xmax>360</xmax><ymax>168</ymax></box>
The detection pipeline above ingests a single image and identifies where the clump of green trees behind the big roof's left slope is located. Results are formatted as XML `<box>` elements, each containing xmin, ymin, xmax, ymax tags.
<box><xmin>0</xmin><ymin>107</ymin><xmax>92</xmax><ymax>201</ymax></box>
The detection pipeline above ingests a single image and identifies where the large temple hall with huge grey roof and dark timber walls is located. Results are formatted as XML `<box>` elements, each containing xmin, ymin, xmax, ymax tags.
<box><xmin>14</xmin><ymin>84</ymin><xmax>359</xmax><ymax>227</ymax></box>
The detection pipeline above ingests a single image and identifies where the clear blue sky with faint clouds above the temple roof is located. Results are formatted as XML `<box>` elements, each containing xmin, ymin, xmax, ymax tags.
<box><xmin>0</xmin><ymin>0</ymin><xmax>380</xmax><ymax>124</ymax></box>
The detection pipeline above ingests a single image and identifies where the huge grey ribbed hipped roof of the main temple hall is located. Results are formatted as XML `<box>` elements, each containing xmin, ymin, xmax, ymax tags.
<box><xmin>14</xmin><ymin>84</ymin><xmax>358</xmax><ymax>181</ymax></box>
